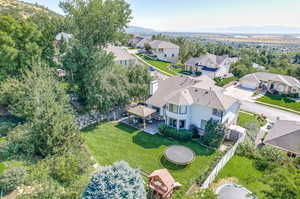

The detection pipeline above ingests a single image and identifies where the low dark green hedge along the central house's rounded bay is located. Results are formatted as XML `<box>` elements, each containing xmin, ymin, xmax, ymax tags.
<box><xmin>158</xmin><ymin>124</ymin><xmax>193</xmax><ymax>141</ymax></box>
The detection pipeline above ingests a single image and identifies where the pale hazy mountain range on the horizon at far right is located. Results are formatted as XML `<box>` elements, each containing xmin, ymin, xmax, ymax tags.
<box><xmin>211</xmin><ymin>26</ymin><xmax>300</xmax><ymax>34</ymax></box>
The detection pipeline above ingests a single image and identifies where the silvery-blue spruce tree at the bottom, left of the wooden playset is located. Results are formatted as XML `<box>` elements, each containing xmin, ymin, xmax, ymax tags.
<box><xmin>82</xmin><ymin>161</ymin><xmax>146</xmax><ymax>199</ymax></box>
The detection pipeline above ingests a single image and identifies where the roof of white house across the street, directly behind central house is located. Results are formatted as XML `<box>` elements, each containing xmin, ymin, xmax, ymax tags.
<box><xmin>185</xmin><ymin>53</ymin><xmax>236</xmax><ymax>67</ymax></box>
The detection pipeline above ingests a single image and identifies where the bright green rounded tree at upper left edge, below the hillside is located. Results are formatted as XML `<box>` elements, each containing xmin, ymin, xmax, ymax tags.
<box><xmin>0</xmin><ymin>16</ymin><xmax>42</xmax><ymax>80</ymax></box>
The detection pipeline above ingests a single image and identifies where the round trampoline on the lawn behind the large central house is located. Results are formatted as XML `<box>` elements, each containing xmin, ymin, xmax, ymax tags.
<box><xmin>164</xmin><ymin>145</ymin><xmax>195</xmax><ymax>165</ymax></box>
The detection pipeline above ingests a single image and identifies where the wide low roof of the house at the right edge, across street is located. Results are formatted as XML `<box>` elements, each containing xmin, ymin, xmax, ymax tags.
<box><xmin>241</xmin><ymin>72</ymin><xmax>300</xmax><ymax>88</ymax></box>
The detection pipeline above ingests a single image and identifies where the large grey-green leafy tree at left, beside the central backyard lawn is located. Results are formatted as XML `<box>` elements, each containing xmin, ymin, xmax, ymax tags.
<box><xmin>0</xmin><ymin>65</ymin><xmax>82</xmax><ymax>157</ymax></box>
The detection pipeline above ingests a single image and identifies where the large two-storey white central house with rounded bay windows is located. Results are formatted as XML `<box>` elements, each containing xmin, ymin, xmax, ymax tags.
<box><xmin>146</xmin><ymin>75</ymin><xmax>240</xmax><ymax>130</ymax></box>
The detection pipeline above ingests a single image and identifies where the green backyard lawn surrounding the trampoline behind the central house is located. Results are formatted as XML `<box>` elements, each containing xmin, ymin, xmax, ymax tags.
<box><xmin>82</xmin><ymin>123</ymin><xmax>217</xmax><ymax>190</ymax></box>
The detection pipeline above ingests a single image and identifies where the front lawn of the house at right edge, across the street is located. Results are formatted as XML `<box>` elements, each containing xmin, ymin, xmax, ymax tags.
<box><xmin>257</xmin><ymin>93</ymin><xmax>300</xmax><ymax>111</ymax></box>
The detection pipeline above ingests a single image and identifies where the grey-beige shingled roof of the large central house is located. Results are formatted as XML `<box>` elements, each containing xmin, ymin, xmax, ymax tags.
<box><xmin>146</xmin><ymin>75</ymin><xmax>237</xmax><ymax>110</ymax></box>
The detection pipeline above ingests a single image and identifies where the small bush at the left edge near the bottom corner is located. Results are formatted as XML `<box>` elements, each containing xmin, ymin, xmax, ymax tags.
<box><xmin>0</xmin><ymin>167</ymin><xmax>26</xmax><ymax>194</ymax></box>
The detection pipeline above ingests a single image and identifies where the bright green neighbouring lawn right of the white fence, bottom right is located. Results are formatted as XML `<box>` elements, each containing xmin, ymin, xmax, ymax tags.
<box><xmin>215</xmin><ymin>155</ymin><xmax>268</xmax><ymax>198</ymax></box>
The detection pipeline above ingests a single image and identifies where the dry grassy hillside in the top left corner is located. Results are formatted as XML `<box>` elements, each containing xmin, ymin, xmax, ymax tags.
<box><xmin>0</xmin><ymin>0</ymin><xmax>58</xmax><ymax>18</ymax></box>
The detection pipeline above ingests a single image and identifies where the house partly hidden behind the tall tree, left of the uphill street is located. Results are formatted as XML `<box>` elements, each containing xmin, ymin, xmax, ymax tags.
<box><xmin>105</xmin><ymin>45</ymin><xmax>138</xmax><ymax>66</ymax></box>
